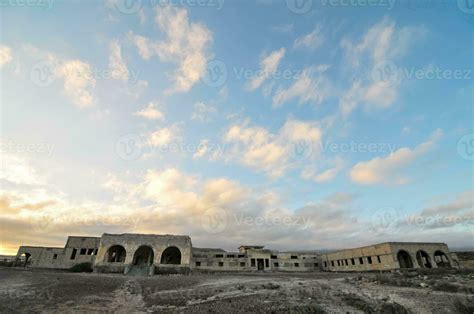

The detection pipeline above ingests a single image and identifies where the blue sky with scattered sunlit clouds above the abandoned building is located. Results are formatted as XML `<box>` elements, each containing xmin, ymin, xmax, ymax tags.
<box><xmin>0</xmin><ymin>0</ymin><xmax>474</xmax><ymax>254</ymax></box>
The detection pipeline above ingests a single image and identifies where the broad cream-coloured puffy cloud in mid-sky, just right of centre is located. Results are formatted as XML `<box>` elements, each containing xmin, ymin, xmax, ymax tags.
<box><xmin>223</xmin><ymin>119</ymin><xmax>322</xmax><ymax>177</ymax></box>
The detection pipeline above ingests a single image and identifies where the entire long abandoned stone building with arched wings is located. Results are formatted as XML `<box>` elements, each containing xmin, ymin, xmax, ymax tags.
<box><xmin>15</xmin><ymin>233</ymin><xmax>459</xmax><ymax>275</ymax></box>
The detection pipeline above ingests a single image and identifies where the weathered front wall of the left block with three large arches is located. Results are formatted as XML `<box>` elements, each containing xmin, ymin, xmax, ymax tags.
<box><xmin>95</xmin><ymin>233</ymin><xmax>192</xmax><ymax>272</ymax></box>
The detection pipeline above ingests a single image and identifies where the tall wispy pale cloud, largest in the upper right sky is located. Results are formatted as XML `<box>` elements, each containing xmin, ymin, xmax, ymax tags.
<box><xmin>339</xmin><ymin>18</ymin><xmax>426</xmax><ymax>116</ymax></box>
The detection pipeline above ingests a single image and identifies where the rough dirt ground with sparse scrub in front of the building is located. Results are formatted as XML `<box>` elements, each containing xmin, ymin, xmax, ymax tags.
<box><xmin>0</xmin><ymin>267</ymin><xmax>474</xmax><ymax>313</ymax></box>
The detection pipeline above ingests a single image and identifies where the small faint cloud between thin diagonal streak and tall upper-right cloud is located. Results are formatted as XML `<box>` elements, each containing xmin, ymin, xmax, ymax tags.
<box><xmin>272</xmin><ymin>65</ymin><xmax>331</xmax><ymax>107</ymax></box>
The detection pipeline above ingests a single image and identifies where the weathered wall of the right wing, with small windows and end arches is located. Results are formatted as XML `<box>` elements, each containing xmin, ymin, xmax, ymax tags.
<box><xmin>320</xmin><ymin>242</ymin><xmax>456</xmax><ymax>271</ymax></box>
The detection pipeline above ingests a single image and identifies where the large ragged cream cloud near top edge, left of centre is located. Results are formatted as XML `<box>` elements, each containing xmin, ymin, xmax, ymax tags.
<box><xmin>128</xmin><ymin>6</ymin><xmax>212</xmax><ymax>93</ymax></box>
